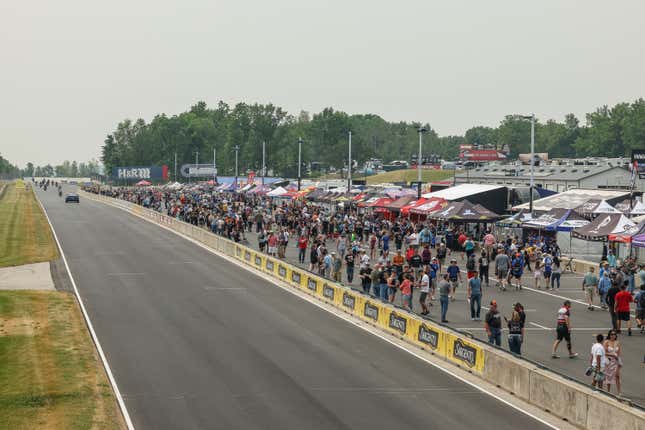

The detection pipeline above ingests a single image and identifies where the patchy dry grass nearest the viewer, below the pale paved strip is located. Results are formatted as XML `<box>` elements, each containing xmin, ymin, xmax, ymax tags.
<box><xmin>0</xmin><ymin>291</ymin><xmax>125</xmax><ymax>430</ymax></box>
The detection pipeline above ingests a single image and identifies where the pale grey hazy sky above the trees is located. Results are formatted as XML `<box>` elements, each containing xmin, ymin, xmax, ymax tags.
<box><xmin>0</xmin><ymin>0</ymin><xmax>645</xmax><ymax>166</ymax></box>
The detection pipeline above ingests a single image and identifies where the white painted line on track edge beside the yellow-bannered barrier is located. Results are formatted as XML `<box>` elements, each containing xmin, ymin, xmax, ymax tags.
<box><xmin>110</xmin><ymin>197</ymin><xmax>559</xmax><ymax>429</ymax></box>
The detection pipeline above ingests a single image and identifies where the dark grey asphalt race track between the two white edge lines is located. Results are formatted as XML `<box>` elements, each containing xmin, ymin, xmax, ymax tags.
<box><xmin>32</xmin><ymin>187</ymin><xmax>547</xmax><ymax>430</ymax></box>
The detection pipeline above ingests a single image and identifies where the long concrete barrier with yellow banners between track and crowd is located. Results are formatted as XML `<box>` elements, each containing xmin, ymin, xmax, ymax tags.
<box><xmin>82</xmin><ymin>192</ymin><xmax>645</xmax><ymax>430</ymax></box>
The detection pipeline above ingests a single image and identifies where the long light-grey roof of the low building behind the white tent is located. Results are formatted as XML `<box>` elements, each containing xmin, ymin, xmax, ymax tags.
<box><xmin>456</xmin><ymin>164</ymin><xmax>629</xmax><ymax>181</ymax></box>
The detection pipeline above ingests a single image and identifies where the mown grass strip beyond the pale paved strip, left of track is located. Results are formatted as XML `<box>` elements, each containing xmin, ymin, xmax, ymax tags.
<box><xmin>0</xmin><ymin>181</ymin><xmax>58</xmax><ymax>267</ymax></box>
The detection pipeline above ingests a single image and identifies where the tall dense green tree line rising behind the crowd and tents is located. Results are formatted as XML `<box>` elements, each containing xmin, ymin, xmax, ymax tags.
<box><xmin>101</xmin><ymin>98</ymin><xmax>645</xmax><ymax>177</ymax></box>
